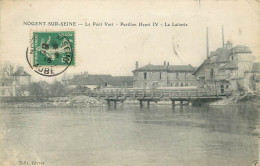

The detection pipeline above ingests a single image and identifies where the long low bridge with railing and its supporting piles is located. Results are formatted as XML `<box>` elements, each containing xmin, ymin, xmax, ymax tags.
<box><xmin>70</xmin><ymin>88</ymin><xmax>230</xmax><ymax>108</ymax></box>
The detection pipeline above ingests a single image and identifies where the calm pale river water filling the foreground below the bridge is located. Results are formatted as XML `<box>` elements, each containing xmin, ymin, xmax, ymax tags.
<box><xmin>0</xmin><ymin>105</ymin><xmax>259</xmax><ymax>166</ymax></box>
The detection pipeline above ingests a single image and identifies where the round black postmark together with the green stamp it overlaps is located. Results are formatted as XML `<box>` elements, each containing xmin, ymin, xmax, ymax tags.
<box><xmin>26</xmin><ymin>31</ymin><xmax>75</xmax><ymax>77</ymax></box>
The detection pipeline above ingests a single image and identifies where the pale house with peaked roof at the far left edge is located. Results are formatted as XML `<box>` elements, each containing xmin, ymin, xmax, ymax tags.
<box><xmin>0</xmin><ymin>67</ymin><xmax>31</xmax><ymax>96</ymax></box>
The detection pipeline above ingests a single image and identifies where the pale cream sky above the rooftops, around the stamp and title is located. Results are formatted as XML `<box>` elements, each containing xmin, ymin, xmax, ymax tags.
<box><xmin>0</xmin><ymin>0</ymin><xmax>260</xmax><ymax>81</ymax></box>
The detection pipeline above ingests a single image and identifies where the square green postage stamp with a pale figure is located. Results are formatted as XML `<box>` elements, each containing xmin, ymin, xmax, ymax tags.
<box><xmin>33</xmin><ymin>31</ymin><xmax>75</xmax><ymax>66</ymax></box>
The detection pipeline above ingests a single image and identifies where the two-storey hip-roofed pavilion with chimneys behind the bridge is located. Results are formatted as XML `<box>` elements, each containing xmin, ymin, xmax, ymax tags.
<box><xmin>133</xmin><ymin>61</ymin><xmax>196</xmax><ymax>89</ymax></box>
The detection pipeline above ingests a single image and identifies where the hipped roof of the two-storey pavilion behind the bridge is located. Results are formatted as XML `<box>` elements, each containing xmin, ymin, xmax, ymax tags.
<box><xmin>133</xmin><ymin>64</ymin><xmax>195</xmax><ymax>72</ymax></box>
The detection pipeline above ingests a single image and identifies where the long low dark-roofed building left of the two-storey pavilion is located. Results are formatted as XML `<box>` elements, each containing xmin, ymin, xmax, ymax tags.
<box><xmin>62</xmin><ymin>72</ymin><xmax>133</xmax><ymax>89</ymax></box>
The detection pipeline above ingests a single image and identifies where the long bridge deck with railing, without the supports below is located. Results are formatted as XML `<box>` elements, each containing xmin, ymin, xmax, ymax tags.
<box><xmin>69</xmin><ymin>89</ymin><xmax>229</xmax><ymax>100</ymax></box>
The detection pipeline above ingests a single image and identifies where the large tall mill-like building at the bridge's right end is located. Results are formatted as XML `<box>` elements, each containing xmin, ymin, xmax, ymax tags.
<box><xmin>193</xmin><ymin>41</ymin><xmax>255</xmax><ymax>93</ymax></box>
